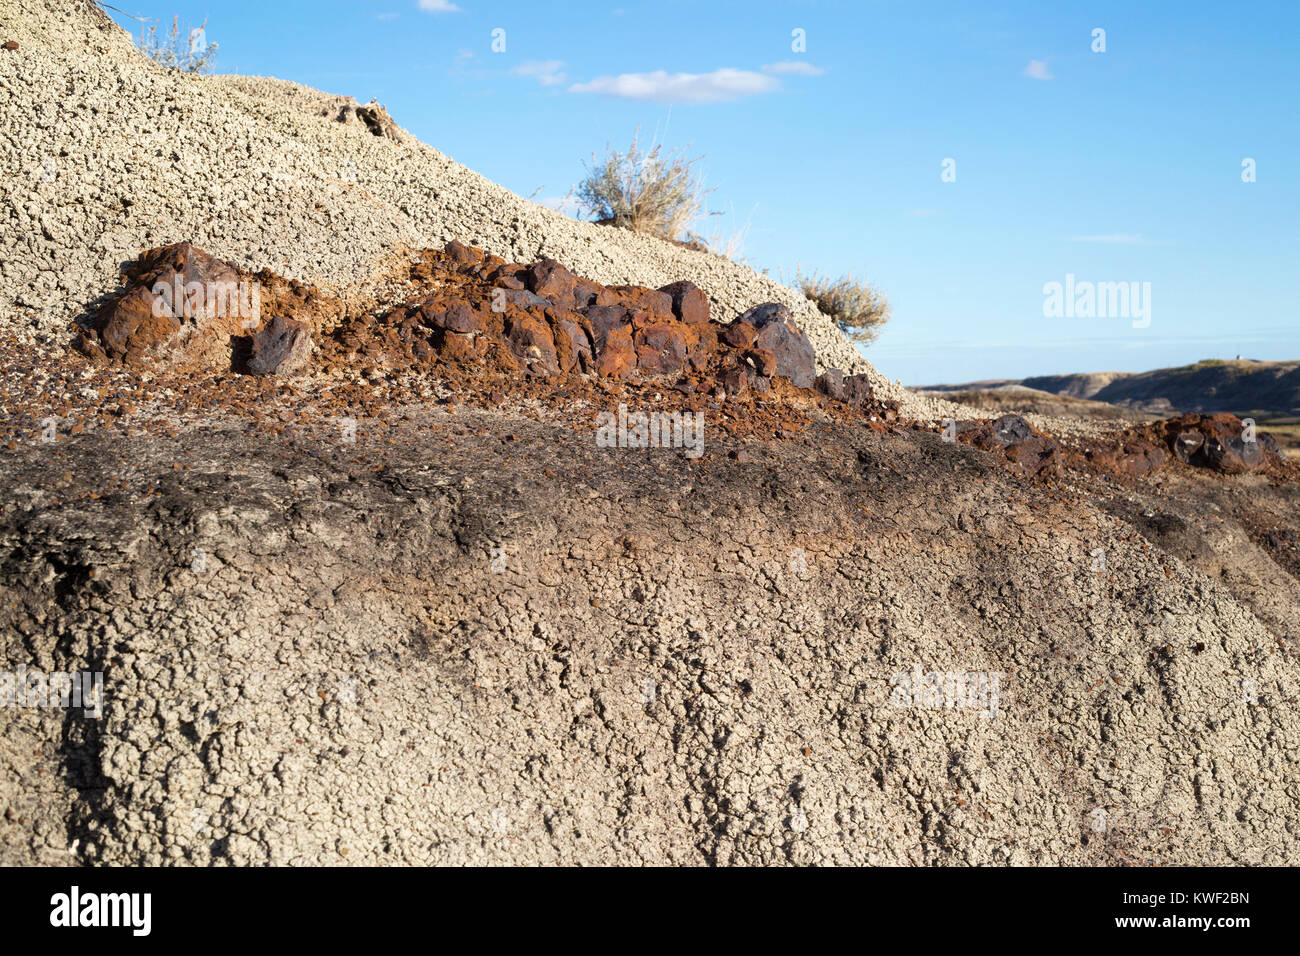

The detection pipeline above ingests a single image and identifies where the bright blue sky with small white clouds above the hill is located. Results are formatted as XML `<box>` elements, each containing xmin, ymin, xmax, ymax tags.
<box><xmin>106</xmin><ymin>0</ymin><xmax>1300</xmax><ymax>385</ymax></box>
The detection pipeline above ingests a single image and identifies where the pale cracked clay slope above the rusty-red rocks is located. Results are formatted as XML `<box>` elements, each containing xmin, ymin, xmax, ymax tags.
<box><xmin>0</xmin><ymin>0</ymin><xmax>970</xmax><ymax>419</ymax></box>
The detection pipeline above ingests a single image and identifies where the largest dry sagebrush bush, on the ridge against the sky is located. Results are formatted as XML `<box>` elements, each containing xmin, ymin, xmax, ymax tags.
<box><xmin>577</xmin><ymin>137</ymin><xmax>709</xmax><ymax>239</ymax></box>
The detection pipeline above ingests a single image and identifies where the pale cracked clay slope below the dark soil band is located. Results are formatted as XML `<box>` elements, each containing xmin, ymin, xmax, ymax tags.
<box><xmin>0</xmin><ymin>412</ymin><xmax>1300</xmax><ymax>865</ymax></box>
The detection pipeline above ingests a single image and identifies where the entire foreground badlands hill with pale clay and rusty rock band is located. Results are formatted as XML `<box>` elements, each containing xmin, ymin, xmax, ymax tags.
<box><xmin>0</xmin><ymin>0</ymin><xmax>1300</xmax><ymax>865</ymax></box>
